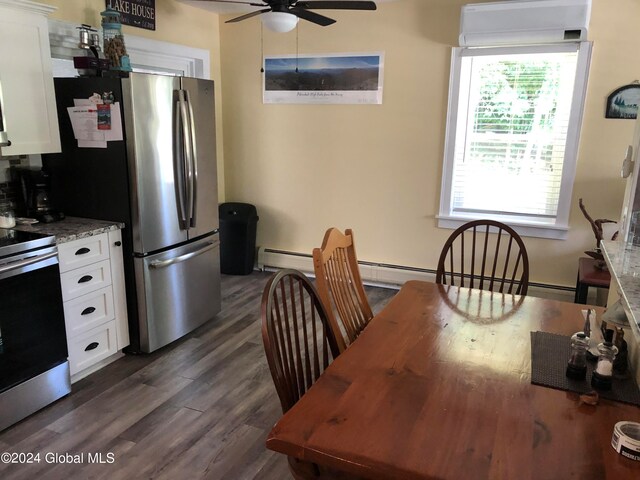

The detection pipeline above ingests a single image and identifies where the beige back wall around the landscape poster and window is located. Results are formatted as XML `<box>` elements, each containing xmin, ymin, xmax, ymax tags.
<box><xmin>220</xmin><ymin>0</ymin><xmax>640</xmax><ymax>286</ymax></box>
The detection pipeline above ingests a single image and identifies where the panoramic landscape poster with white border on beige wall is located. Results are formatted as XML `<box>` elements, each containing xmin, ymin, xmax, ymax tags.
<box><xmin>263</xmin><ymin>53</ymin><xmax>384</xmax><ymax>105</ymax></box>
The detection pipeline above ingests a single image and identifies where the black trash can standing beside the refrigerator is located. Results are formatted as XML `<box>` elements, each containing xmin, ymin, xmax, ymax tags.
<box><xmin>218</xmin><ymin>202</ymin><xmax>258</xmax><ymax>275</ymax></box>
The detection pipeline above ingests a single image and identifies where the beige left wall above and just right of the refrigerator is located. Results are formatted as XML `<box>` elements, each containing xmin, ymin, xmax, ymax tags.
<box><xmin>38</xmin><ymin>0</ymin><xmax>224</xmax><ymax>200</ymax></box>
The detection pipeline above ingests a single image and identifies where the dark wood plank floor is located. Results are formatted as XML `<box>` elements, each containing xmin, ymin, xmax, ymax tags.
<box><xmin>0</xmin><ymin>272</ymin><xmax>396</xmax><ymax>480</ymax></box>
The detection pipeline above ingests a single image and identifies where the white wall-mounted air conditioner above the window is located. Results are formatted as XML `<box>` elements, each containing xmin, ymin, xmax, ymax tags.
<box><xmin>460</xmin><ymin>0</ymin><xmax>591</xmax><ymax>47</ymax></box>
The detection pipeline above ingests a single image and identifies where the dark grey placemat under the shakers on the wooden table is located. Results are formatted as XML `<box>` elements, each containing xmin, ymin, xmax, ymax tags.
<box><xmin>531</xmin><ymin>332</ymin><xmax>640</xmax><ymax>406</ymax></box>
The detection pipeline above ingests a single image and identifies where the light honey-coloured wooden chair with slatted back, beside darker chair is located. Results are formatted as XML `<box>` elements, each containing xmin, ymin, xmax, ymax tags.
<box><xmin>313</xmin><ymin>228</ymin><xmax>373</xmax><ymax>352</ymax></box>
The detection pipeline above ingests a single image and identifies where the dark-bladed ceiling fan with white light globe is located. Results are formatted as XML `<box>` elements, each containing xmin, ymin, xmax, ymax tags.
<box><xmin>192</xmin><ymin>0</ymin><xmax>376</xmax><ymax>32</ymax></box>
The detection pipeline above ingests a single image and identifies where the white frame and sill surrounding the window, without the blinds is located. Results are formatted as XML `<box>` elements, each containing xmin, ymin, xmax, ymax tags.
<box><xmin>436</xmin><ymin>42</ymin><xmax>592</xmax><ymax>240</ymax></box>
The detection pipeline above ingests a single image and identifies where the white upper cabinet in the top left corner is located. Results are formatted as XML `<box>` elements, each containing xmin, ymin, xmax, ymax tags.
<box><xmin>0</xmin><ymin>0</ymin><xmax>60</xmax><ymax>155</ymax></box>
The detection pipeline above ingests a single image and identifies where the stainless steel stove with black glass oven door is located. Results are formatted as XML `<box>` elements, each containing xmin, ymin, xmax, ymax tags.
<box><xmin>0</xmin><ymin>228</ymin><xmax>71</xmax><ymax>431</ymax></box>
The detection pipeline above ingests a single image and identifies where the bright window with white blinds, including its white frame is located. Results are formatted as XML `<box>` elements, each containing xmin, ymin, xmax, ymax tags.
<box><xmin>440</xmin><ymin>42</ymin><xmax>588</xmax><ymax>237</ymax></box>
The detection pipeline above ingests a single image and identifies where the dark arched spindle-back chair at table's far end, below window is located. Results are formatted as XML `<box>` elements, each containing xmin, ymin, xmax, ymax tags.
<box><xmin>436</xmin><ymin>220</ymin><xmax>529</xmax><ymax>295</ymax></box>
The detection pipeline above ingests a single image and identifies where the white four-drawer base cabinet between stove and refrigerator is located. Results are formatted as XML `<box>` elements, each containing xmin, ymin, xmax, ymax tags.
<box><xmin>58</xmin><ymin>230</ymin><xmax>129</xmax><ymax>382</ymax></box>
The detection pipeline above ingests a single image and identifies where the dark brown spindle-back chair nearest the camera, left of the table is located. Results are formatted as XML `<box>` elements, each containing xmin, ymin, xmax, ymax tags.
<box><xmin>261</xmin><ymin>269</ymin><xmax>356</xmax><ymax>480</ymax></box>
